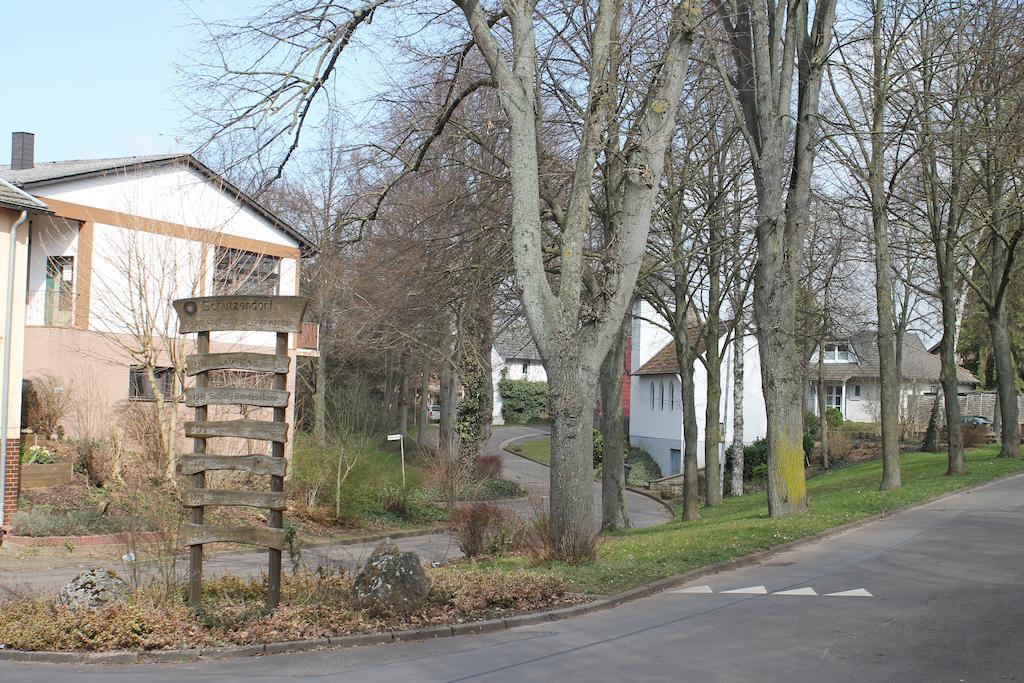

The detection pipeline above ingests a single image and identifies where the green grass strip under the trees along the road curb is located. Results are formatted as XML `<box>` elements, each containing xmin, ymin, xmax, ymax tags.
<box><xmin>467</xmin><ymin>440</ymin><xmax>1024</xmax><ymax>594</ymax></box>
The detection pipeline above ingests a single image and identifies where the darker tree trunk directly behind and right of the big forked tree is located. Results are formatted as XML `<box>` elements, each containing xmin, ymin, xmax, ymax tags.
<box><xmin>600</xmin><ymin>314</ymin><xmax>633</xmax><ymax>531</ymax></box>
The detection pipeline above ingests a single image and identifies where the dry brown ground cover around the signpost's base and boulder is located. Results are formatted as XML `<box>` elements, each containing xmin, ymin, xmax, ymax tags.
<box><xmin>0</xmin><ymin>568</ymin><xmax>583</xmax><ymax>650</ymax></box>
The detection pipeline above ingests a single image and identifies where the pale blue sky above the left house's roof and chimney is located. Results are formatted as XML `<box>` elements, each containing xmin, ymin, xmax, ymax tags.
<box><xmin>0</xmin><ymin>0</ymin><xmax>385</xmax><ymax>163</ymax></box>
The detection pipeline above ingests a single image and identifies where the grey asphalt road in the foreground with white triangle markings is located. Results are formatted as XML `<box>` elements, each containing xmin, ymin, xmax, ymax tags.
<box><xmin>0</xmin><ymin>476</ymin><xmax>1024</xmax><ymax>683</ymax></box>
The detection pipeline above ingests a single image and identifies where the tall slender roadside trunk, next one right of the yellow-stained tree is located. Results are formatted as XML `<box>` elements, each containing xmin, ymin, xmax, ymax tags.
<box><xmin>867</xmin><ymin>0</ymin><xmax>902</xmax><ymax>490</ymax></box>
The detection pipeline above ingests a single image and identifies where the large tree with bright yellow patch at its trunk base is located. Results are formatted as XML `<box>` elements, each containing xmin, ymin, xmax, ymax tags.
<box><xmin>715</xmin><ymin>0</ymin><xmax>836</xmax><ymax>516</ymax></box>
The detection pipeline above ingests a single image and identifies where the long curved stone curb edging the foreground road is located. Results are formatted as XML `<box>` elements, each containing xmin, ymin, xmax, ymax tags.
<box><xmin>6</xmin><ymin>472</ymin><xmax>1024</xmax><ymax>665</ymax></box>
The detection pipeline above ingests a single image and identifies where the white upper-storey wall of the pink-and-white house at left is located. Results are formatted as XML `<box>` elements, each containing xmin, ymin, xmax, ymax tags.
<box><xmin>30</xmin><ymin>165</ymin><xmax>298</xmax><ymax>347</ymax></box>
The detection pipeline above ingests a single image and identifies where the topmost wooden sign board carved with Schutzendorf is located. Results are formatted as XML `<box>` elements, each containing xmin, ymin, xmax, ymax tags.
<box><xmin>174</xmin><ymin>295</ymin><xmax>309</xmax><ymax>334</ymax></box>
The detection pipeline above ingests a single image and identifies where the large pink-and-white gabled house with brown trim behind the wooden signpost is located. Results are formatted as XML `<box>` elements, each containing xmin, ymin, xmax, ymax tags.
<box><xmin>0</xmin><ymin>133</ymin><xmax>316</xmax><ymax>511</ymax></box>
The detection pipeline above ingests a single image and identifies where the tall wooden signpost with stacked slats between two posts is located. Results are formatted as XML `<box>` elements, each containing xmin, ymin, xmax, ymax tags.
<box><xmin>174</xmin><ymin>295</ymin><xmax>307</xmax><ymax>607</ymax></box>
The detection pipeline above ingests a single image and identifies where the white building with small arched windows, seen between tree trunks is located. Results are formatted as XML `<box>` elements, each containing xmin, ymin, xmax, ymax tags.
<box><xmin>630</xmin><ymin>301</ymin><xmax>767</xmax><ymax>476</ymax></box>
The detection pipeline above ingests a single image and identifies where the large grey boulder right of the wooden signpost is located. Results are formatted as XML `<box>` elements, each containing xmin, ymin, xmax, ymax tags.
<box><xmin>353</xmin><ymin>539</ymin><xmax>430</xmax><ymax>613</ymax></box>
